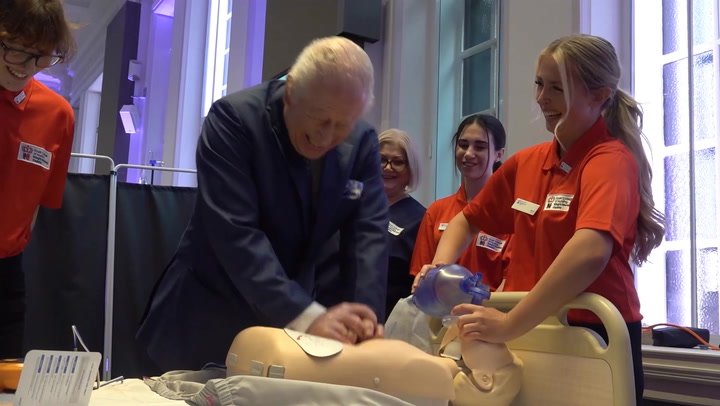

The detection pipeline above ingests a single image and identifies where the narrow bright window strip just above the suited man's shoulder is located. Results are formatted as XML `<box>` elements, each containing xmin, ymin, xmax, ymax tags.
<box><xmin>203</xmin><ymin>0</ymin><xmax>233</xmax><ymax>116</ymax></box>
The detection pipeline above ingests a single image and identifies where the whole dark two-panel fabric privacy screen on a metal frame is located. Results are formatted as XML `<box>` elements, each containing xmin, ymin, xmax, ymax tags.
<box><xmin>23</xmin><ymin>174</ymin><xmax>196</xmax><ymax>377</ymax></box>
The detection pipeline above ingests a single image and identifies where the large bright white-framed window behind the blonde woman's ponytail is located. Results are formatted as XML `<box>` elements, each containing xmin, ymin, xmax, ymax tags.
<box><xmin>634</xmin><ymin>0</ymin><xmax>720</xmax><ymax>334</ymax></box>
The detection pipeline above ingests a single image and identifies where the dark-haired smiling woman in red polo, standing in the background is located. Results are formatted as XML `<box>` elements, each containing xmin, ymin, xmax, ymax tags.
<box><xmin>410</xmin><ymin>114</ymin><xmax>509</xmax><ymax>290</ymax></box>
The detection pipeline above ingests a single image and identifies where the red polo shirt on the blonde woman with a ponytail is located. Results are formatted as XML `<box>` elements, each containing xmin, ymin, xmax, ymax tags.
<box><xmin>463</xmin><ymin>118</ymin><xmax>642</xmax><ymax>323</ymax></box>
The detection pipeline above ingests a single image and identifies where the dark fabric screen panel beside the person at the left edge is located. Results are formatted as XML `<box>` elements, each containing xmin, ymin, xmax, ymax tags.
<box><xmin>23</xmin><ymin>174</ymin><xmax>110</xmax><ymax>352</ymax></box>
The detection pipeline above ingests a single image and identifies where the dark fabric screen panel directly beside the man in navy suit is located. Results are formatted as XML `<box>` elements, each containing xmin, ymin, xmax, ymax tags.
<box><xmin>112</xmin><ymin>183</ymin><xmax>196</xmax><ymax>377</ymax></box>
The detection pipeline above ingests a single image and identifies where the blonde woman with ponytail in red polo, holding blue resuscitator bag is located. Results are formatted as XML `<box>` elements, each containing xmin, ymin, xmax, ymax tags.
<box><xmin>421</xmin><ymin>35</ymin><xmax>665</xmax><ymax>402</ymax></box>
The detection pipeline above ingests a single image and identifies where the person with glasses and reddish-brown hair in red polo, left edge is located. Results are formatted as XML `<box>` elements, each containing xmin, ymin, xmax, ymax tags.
<box><xmin>0</xmin><ymin>0</ymin><xmax>75</xmax><ymax>359</ymax></box>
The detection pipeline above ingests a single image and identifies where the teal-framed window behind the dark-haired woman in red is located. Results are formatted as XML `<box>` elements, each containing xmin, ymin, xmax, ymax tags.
<box><xmin>435</xmin><ymin>0</ymin><xmax>500</xmax><ymax>198</ymax></box>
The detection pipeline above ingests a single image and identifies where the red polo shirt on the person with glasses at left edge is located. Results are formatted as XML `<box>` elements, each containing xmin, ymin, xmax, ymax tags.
<box><xmin>0</xmin><ymin>79</ymin><xmax>75</xmax><ymax>258</ymax></box>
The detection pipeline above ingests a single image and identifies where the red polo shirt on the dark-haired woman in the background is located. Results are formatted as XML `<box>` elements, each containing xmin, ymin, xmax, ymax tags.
<box><xmin>410</xmin><ymin>185</ymin><xmax>509</xmax><ymax>291</ymax></box>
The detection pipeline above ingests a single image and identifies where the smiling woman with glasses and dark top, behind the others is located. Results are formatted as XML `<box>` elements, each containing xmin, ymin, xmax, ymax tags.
<box><xmin>378</xmin><ymin>128</ymin><xmax>425</xmax><ymax>315</ymax></box>
